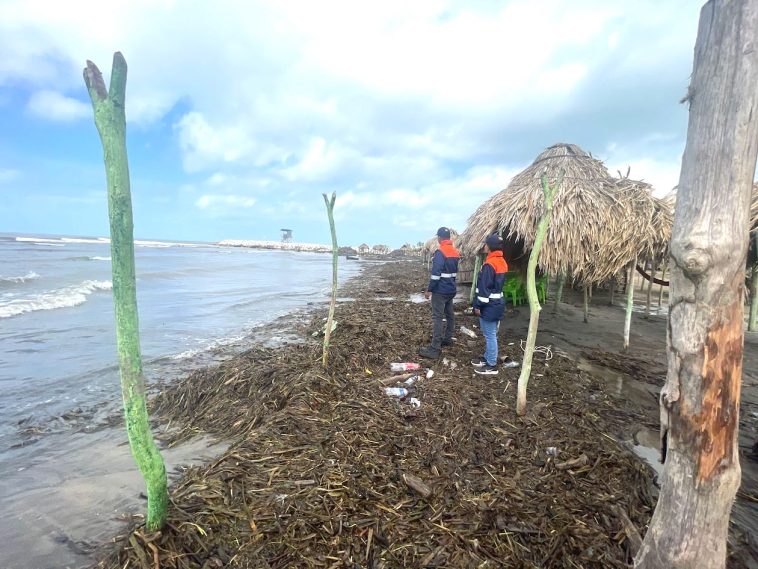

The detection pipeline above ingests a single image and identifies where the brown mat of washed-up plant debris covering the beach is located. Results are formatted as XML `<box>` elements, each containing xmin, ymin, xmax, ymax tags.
<box><xmin>99</xmin><ymin>262</ymin><xmax>654</xmax><ymax>568</ymax></box>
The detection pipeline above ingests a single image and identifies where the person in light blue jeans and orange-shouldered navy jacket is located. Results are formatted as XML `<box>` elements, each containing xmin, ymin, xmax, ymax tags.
<box><xmin>471</xmin><ymin>233</ymin><xmax>508</xmax><ymax>375</ymax></box>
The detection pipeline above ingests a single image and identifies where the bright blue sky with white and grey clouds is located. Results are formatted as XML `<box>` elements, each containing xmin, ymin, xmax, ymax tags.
<box><xmin>0</xmin><ymin>0</ymin><xmax>702</xmax><ymax>247</ymax></box>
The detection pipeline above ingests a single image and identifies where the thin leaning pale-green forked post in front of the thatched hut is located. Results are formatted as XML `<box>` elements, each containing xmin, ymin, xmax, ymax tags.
<box><xmin>516</xmin><ymin>173</ymin><xmax>560</xmax><ymax>415</ymax></box>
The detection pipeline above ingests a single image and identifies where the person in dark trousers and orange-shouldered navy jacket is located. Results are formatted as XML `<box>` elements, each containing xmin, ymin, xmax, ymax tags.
<box><xmin>418</xmin><ymin>227</ymin><xmax>460</xmax><ymax>359</ymax></box>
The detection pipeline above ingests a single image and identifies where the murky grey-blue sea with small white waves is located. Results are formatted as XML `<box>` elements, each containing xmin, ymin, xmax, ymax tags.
<box><xmin>0</xmin><ymin>234</ymin><xmax>361</xmax><ymax>568</ymax></box>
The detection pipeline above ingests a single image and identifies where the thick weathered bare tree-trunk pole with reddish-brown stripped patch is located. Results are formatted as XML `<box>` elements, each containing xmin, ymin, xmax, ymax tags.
<box><xmin>635</xmin><ymin>0</ymin><xmax>758</xmax><ymax>569</ymax></box>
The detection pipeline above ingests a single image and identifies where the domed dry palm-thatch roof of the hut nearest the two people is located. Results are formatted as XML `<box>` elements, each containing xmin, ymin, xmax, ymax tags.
<box><xmin>461</xmin><ymin>144</ymin><xmax>672</xmax><ymax>282</ymax></box>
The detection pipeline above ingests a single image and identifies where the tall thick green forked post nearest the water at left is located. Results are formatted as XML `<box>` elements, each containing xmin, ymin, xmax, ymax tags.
<box><xmin>84</xmin><ymin>52</ymin><xmax>168</xmax><ymax>532</ymax></box>
